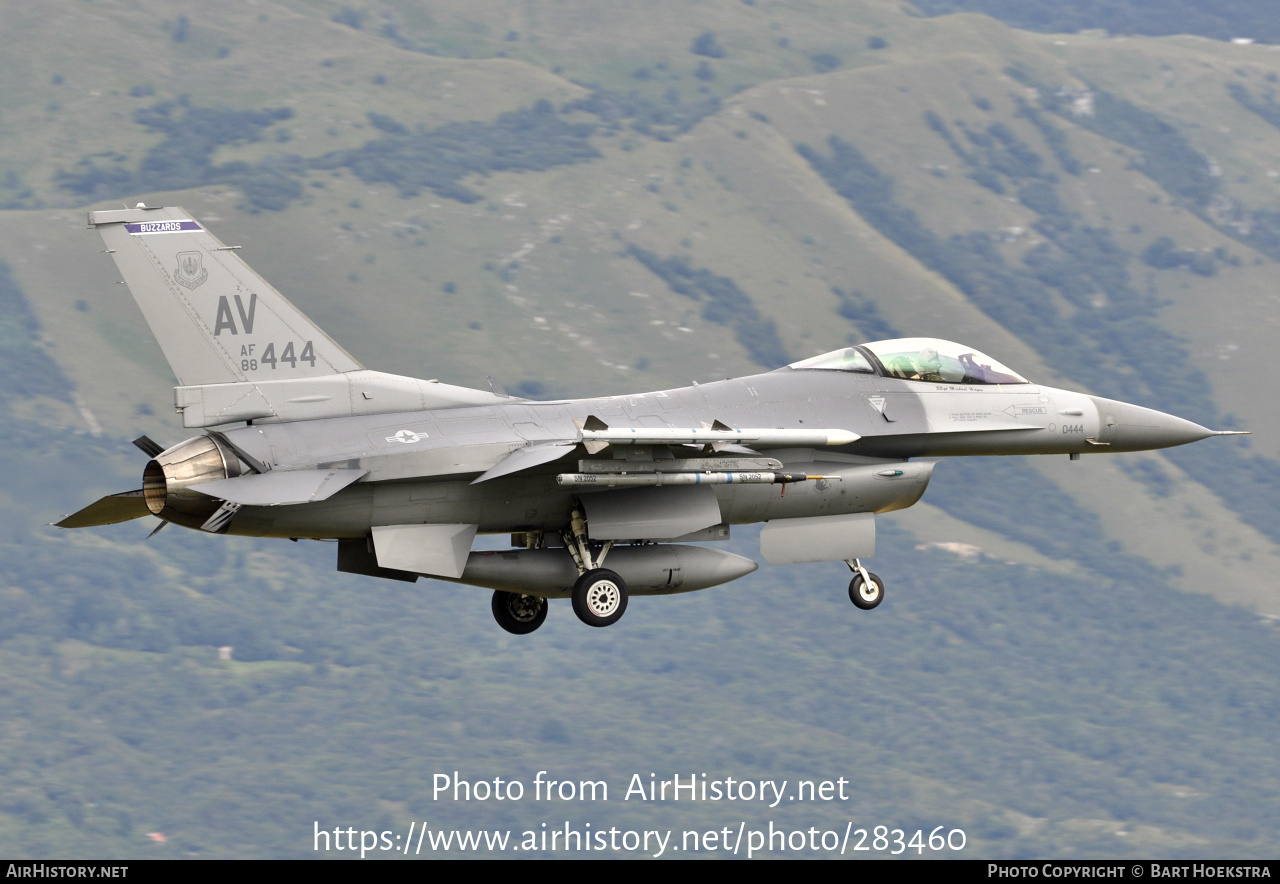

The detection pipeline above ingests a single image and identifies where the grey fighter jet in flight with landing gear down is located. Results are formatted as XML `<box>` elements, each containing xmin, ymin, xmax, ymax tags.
<box><xmin>58</xmin><ymin>205</ymin><xmax>1229</xmax><ymax>635</ymax></box>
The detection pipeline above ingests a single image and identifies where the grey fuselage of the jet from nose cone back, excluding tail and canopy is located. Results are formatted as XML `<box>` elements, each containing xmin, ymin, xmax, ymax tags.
<box><xmin>165</xmin><ymin>368</ymin><xmax>1192</xmax><ymax>537</ymax></box>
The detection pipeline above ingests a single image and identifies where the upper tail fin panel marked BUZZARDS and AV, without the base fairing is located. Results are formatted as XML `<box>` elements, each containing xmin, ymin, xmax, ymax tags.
<box><xmin>88</xmin><ymin>206</ymin><xmax>362</xmax><ymax>386</ymax></box>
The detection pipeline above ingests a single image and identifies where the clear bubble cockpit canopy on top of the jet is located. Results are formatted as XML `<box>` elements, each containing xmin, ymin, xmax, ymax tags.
<box><xmin>788</xmin><ymin>338</ymin><xmax>1028</xmax><ymax>384</ymax></box>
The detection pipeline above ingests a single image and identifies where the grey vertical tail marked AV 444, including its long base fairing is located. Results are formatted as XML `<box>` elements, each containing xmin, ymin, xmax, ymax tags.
<box><xmin>88</xmin><ymin>206</ymin><xmax>504</xmax><ymax>427</ymax></box>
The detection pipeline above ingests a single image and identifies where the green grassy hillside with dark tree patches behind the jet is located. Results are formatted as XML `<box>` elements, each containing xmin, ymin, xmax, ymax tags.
<box><xmin>0</xmin><ymin>0</ymin><xmax>1280</xmax><ymax>856</ymax></box>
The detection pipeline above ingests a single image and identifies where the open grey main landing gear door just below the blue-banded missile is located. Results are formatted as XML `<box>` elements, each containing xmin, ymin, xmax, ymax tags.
<box><xmin>582</xmin><ymin>485</ymin><xmax>723</xmax><ymax>540</ymax></box>
